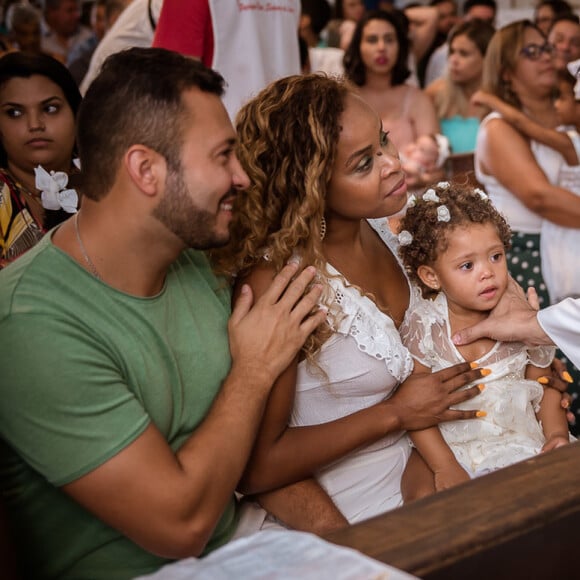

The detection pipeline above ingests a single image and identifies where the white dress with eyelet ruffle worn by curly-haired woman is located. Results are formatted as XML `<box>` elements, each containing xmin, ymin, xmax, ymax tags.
<box><xmin>291</xmin><ymin>220</ymin><xmax>413</xmax><ymax>523</ymax></box>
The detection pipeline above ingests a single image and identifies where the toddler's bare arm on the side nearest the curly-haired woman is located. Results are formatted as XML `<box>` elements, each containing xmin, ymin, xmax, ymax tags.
<box><xmin>409</xmin><ymin>361</ymin><xmax>470</xmax><ymax>491</ymax></box>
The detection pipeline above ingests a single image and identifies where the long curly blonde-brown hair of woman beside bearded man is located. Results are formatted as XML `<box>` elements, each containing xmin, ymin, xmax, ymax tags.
<box><xmin>212</xmin><ymin>74</ymin><xmax>352</xmax><ymax>360</ymax></box>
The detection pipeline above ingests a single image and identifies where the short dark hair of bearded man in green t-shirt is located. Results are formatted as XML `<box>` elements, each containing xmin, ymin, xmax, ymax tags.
<box><xmin>77</xmin><ymin>48</ymin><xmax>224</xmax><ymax>200</ymax></box>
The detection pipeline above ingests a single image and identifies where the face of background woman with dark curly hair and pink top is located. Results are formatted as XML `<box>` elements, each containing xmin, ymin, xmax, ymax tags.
<box><xmin>360</xmin><ymin>20</ymin><xmax>399</xmax><ymax>74</ymax></box>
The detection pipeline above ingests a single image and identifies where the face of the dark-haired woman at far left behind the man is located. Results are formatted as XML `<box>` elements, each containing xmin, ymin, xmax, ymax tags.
<box><xmin>0</xmin><ymin>75</ymin><xmax>75</xmax><ymax>172</ymax></box>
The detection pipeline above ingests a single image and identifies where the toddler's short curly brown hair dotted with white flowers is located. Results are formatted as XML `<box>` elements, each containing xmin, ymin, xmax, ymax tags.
<box><xmin>399</xmin><ymin>182</ymin><xmax>511</xmax><ymax>298</ymax></box>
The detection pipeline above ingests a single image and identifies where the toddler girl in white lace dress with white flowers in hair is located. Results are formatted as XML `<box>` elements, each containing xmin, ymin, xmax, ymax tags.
<box><xmin>400</xmin><ymin>183</ymin><xmax>570</xmax><ymax>494</ymax></box>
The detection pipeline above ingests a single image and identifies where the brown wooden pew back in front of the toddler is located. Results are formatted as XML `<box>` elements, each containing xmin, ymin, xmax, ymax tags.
<box><xmin>326</xmin><ymin>442</ymin><xmax>580</xmax><ymax>580</ymax></box>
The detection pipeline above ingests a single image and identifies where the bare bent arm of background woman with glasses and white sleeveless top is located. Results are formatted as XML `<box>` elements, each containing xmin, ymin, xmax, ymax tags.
<box><xmin>477</xmin><ymin>119</ymin><xmax>580</xmax><ymax>228</ymax></box>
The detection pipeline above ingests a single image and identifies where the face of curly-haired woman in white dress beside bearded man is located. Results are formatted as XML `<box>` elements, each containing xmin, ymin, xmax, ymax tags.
<box><xmin>326</xmin><ymin>94</ymin><xmax>407</xmax><ymax>220</ymax></box>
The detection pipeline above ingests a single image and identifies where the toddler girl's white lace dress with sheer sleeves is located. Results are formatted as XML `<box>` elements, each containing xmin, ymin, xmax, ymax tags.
<box><xmin>401</xmin><ymin>291</ymin><xmax>554</xmax><ymax>476</ymax></box>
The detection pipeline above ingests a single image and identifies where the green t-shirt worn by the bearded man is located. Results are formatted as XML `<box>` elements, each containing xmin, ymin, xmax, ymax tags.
<box><xmin>0</xmin><ymin>235</ymin><xmax>237</xmax><ymax>580</ymax></box>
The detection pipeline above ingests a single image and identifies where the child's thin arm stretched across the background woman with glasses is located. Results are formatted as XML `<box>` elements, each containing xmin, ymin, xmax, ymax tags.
<box><xmin>471</xmin><ymin>91</ymin><xmax>578</xmax><ymax>165</ymax></box>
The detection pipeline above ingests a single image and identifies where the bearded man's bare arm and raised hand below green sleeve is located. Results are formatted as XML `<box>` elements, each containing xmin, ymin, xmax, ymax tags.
<box><xmin>63</xmin><ymin>265</ymin><xmax>325</xmax><ymax>558</ymax></box>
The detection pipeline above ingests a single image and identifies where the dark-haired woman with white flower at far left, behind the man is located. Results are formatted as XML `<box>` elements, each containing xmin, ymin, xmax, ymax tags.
<box><xmin>0</xmin><ymin>52</ymin><xmax>81</xmax><ymax>268</ymax></box>
